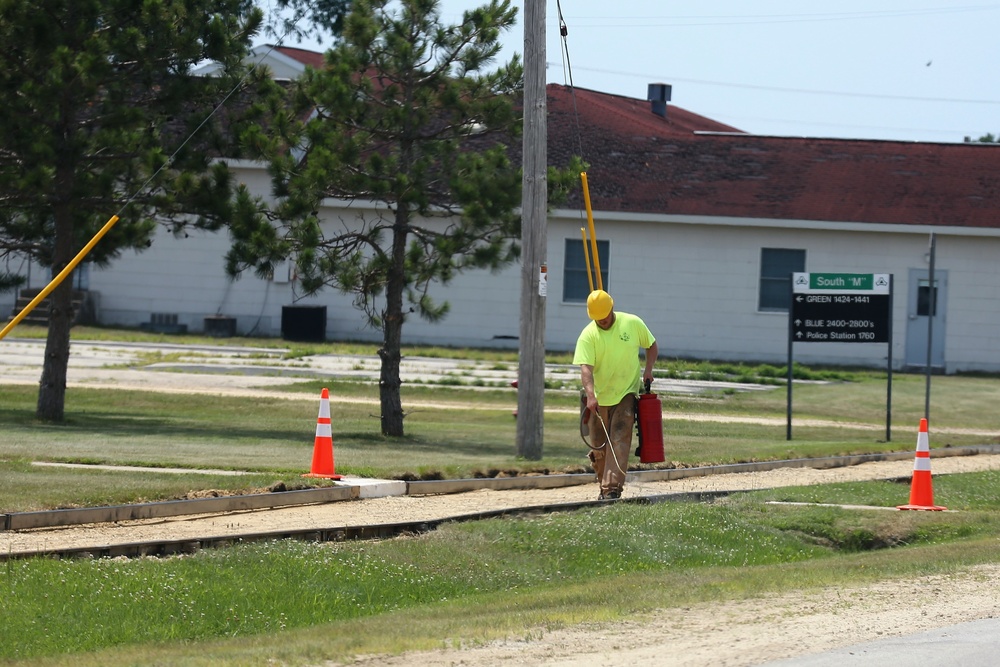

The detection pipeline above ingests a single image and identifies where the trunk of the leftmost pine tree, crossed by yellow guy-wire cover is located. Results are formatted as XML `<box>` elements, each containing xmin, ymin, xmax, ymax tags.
<box><xmin>35</xmin><ymin>210</ymin><xmax>73</xmax><ymax>422</ymax></box>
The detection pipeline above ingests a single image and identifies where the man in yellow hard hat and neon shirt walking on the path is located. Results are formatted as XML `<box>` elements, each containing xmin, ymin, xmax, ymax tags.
<box><xmin>573</xmin><ymin>290</ymin><xmax>658</xmax><ymax>500</ymax></box>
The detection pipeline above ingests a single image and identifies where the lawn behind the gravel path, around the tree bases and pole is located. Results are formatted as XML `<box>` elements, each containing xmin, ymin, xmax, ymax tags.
<box><xmin>0</xmin><ymin>354</ymin><xmax>1000</xmax><ymax>512</ymax></box>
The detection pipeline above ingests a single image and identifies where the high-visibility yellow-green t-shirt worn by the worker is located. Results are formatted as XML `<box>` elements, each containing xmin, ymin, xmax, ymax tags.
<box><xmin>573</xmin><ymin>311</ymin><xmax>656</xmax><ymax>405</ymax></box>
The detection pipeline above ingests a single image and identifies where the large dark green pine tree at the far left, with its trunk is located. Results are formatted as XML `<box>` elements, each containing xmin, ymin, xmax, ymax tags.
<box><xmin>0</xmin><ymin>0</ymin><xmax>272</xmax><ymax>421</ymax></box>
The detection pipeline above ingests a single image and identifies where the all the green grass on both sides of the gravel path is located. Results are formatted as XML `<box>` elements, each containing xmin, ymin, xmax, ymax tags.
<box><xmin>0</xmin><ymin>327</ymin><xmax>1000</xmax><ymax>667</ymax></box>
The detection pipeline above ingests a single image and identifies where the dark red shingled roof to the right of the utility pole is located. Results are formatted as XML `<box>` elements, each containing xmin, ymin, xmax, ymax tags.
<box><xmin>547</xmin><ymin>84</ymin><xmax>1000</xmax><ymax>227</ymax></box>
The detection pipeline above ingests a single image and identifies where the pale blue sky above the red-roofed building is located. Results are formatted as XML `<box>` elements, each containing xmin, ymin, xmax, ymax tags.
<box><xmin>266</xmin><ymin>0</ymin><xmax>1000</xmax><ymax>142</ymax></box>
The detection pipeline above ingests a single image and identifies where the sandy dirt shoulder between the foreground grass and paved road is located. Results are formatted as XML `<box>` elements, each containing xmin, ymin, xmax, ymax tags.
<box><xmin>342</xmin><ymin>565</ymin><xmax>1000</xmax><ymax>667</ymax></box>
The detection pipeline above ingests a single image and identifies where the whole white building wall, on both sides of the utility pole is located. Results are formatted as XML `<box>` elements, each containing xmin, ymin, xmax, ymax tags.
<box><xmin>72</xmin><ymin>160</ymin><xmax>1000</xmax><ymax>372</ymax></box>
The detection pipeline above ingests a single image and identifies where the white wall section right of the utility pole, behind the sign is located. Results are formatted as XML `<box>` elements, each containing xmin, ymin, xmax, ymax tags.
<box><xmin>546</xmin><ymin>214</ymin><xmax>1000</xmax><ymax>372</ymax></box>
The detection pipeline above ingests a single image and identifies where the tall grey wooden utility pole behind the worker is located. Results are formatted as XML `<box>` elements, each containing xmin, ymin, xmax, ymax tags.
<box><xmin>517</xmin><ymin>0</ymin><xmax>548</xmax><ymax>461</ymax></box>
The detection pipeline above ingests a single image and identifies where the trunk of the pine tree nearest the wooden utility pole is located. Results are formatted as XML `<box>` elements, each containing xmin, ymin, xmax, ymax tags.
<box><xmin>378</xmin><ymin>206</ymin><xmax>408</xmax><ymax>437</ymax></box>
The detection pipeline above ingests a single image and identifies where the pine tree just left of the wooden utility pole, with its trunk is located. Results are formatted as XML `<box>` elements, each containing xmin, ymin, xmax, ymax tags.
<box><xmin>229</xmin><ymin>0</ymin><xmax>580</xmax><ymax>436</ymax></box>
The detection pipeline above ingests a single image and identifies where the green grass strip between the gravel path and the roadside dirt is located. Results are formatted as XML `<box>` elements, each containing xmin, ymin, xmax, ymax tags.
<box><xmin>0</xmin><ymin>472</ymin><xmax>1000</xmax><ymax>666</ymax></box>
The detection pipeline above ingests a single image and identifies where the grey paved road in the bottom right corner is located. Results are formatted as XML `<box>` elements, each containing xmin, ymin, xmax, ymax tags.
<box><xmin>762</xmin><ymin>618</ymin><xmax>1000</xmax><ymax>667</ymax></box>
